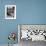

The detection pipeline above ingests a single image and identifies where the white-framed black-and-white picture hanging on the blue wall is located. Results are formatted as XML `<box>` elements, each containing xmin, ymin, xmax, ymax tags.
<box><xmin>5</xmin><ymin>5</ymin><xmax>16</xmax><ymax>19</ymax></box>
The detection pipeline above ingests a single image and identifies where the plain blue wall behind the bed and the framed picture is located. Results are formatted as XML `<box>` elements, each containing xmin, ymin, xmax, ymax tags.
<box><xmin>0</xmin><ymin>0</ymin><xmax>46</xmax><ymax>43</ymax></box>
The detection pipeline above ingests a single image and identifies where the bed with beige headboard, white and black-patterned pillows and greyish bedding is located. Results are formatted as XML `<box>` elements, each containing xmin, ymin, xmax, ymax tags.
<box><xmin>18</xmin><ymin>24</ymin><xmax>46</xmax><ymax>46</ymax></box>
